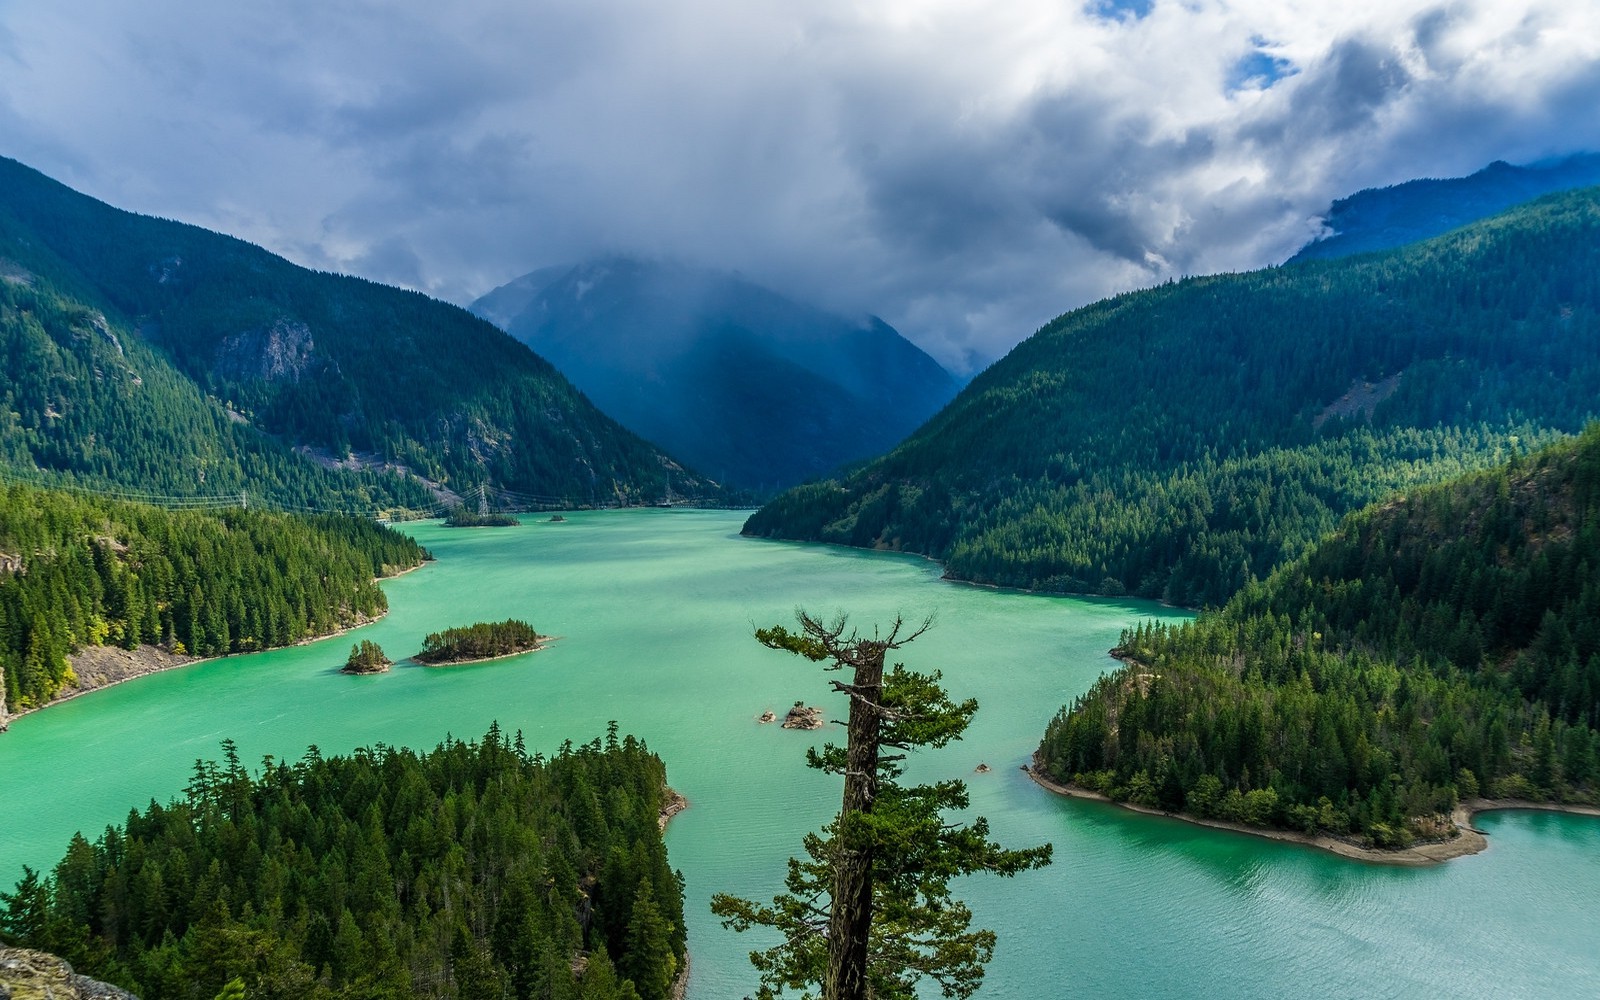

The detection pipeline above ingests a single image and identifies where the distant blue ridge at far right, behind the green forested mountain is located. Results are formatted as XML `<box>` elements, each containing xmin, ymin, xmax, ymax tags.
<box><xmin>1288</xmin><ymin>154</ymin><xmax>1600</xmax><ymax>264</ymax></box>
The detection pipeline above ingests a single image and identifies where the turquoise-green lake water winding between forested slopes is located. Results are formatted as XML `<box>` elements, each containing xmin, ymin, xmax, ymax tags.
<box><xmin>0</xmin><ymin>510</ymin><xmax>1600</xmax><ymax>1000</ymax></box>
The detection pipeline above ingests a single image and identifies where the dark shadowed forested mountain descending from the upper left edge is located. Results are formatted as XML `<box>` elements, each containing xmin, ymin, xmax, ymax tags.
<box><xmin>0</xmin><ymin>160</ymin><xmax>715</xmax><ymax>502</ymax></box>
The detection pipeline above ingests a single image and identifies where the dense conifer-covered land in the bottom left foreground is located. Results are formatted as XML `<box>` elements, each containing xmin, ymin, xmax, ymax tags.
<box><xmin>0</xmin><ymin>728</ymin><xmax>685</xmax><ymax>1000</ymax></box>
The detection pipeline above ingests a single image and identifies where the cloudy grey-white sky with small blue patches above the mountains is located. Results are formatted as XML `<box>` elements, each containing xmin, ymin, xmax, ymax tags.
<box><xmin>0</xmin><ymin>0</ymin><xmax>1600</xmax><ymax>371</ymax></box>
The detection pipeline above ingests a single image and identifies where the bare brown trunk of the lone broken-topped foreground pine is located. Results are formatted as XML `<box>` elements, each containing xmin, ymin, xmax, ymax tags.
<box><xmin>822</xmin><ymin>642</ymin><xmax>888</xmax><ymax>1000</ymax></box>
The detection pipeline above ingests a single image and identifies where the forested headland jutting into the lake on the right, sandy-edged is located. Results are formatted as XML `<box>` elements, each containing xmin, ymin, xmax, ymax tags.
<box><xmin>1040</xmin><ymin>424</ymin><xmax>1600</xmax><ymax>846</ymax></box>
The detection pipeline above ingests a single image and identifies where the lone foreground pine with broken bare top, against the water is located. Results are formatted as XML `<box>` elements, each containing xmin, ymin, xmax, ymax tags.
<box><xmin>712</xmin><ymin>611</ymin><xmax>1051</xmax><ymax>1000</ymax></box>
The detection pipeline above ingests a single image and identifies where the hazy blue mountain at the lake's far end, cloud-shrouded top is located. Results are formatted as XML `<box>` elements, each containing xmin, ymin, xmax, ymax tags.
<box><xmin>472</xmin><ymin>258</ymin><xmax>958</xmax><ymax>493</ymax></box>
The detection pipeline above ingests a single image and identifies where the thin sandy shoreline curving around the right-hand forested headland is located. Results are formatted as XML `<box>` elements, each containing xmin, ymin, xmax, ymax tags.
<box><xmin>1022</xmin><ymin>758</ymin><xmax>1600</xmax><ymax>867</ymax></box>
